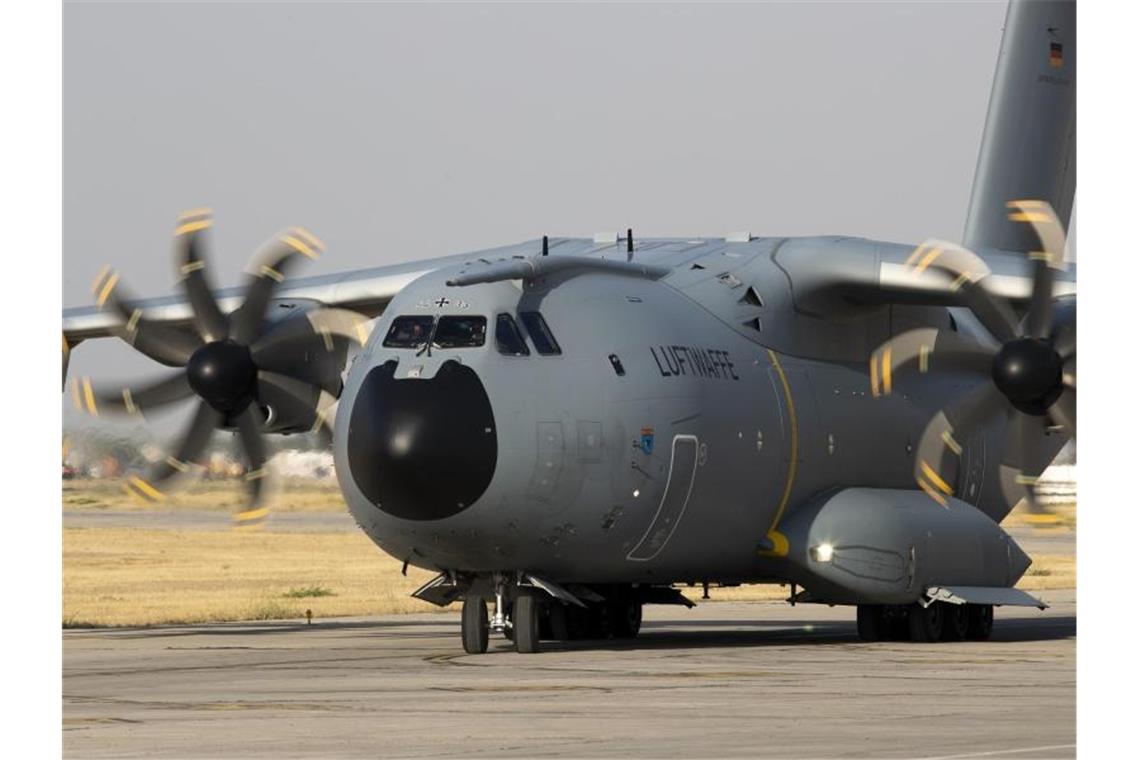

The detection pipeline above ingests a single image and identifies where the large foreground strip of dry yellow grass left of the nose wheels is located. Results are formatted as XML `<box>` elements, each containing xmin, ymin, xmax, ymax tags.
<box><xmin>64</xmin><ymin>528</ymin><xmax>435</xmax><ymax>627</ymax></box>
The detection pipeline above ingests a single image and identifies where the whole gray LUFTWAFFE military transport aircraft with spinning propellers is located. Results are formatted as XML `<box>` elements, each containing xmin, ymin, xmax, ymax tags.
<box><xmin>64</xmin><ymin>1</ymin><xmax>1076</xmax><ymax>652</ymax></box>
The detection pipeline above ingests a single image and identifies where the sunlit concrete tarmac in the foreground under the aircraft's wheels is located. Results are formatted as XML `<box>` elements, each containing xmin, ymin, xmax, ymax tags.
<box><xmin>63</xmin><ymin>590</ymin><xmax>1076</xmax><ymax>759</ymax></box>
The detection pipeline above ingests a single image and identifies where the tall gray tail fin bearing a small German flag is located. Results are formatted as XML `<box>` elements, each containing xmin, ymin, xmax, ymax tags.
<box><xmin>963</xmin><ymin>0</ymin><xmax>1076</xmax><ymax>251</ymax></box>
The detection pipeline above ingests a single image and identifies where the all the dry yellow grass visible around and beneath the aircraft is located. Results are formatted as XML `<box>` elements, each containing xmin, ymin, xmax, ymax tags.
<box><xmin>63</xmin><ymin>481</ymin><xmax>1076</xmax><ymax>627</ymax></box>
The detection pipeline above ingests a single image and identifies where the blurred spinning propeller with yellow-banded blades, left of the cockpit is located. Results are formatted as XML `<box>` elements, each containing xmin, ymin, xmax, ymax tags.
<box><xmin>65</xmin><ymin>209</ymin><xmax>368</xmax><ymax>528</ymax></box>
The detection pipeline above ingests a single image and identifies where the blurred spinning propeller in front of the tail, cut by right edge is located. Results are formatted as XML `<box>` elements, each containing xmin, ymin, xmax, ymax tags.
<box><xmin>870</xmin><ymin>201</ymin><xmax>1076</xmax><ymax>522</ymax></box>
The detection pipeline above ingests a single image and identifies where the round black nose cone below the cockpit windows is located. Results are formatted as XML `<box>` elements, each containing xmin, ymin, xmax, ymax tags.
<box><xmin>348</xmin><ymin>361</ymin><xmax>498</xmax><ymax>520</ymax></box>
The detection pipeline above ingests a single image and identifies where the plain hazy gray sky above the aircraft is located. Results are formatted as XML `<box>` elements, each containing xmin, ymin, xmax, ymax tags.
<box><xmin>63</xmin><ymin>1</ymin><xmax>1005</xmax><ymax>428</ymax></box>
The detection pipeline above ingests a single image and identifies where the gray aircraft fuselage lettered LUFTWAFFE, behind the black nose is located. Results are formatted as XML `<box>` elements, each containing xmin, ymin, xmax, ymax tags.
<box><xmin>334</xmin><ymin>238</ymin><xmax>1059</xmax><ymax>583</ymax></box>
